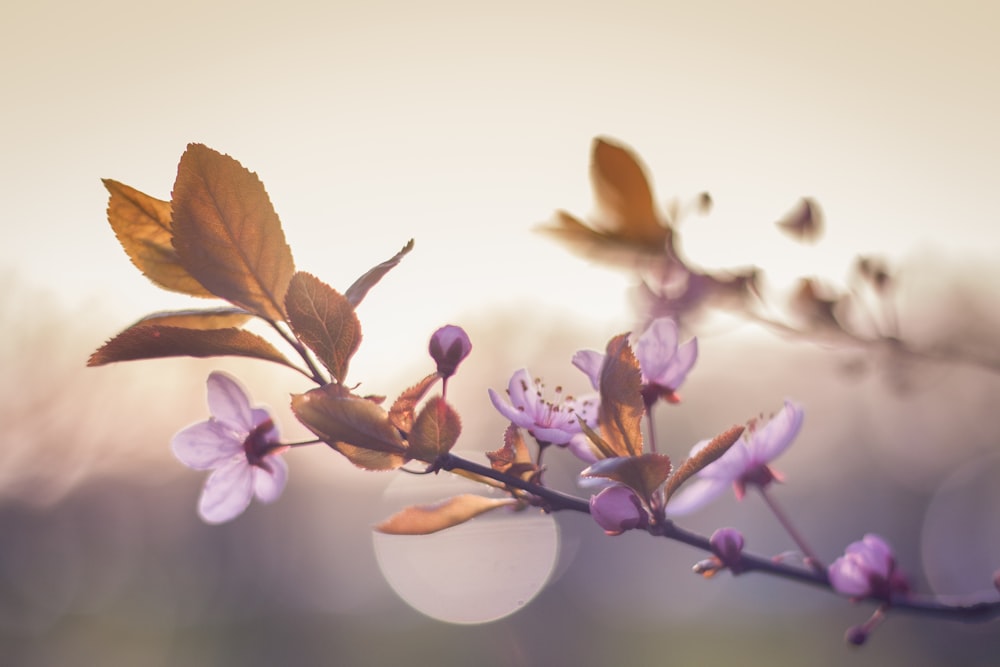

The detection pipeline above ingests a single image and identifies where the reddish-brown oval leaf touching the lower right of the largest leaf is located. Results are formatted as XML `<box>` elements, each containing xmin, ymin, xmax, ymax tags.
<box><xmin>285</xmin><ymin>271</ymin><xmax>361</xmax><ymax>382</ymax></box>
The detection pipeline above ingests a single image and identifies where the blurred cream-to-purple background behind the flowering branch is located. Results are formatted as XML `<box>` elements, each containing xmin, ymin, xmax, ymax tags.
<box><xmin>0</xmin><ymin>0</ymin><xmax>1000</xmax><ymax>666</ymax></box>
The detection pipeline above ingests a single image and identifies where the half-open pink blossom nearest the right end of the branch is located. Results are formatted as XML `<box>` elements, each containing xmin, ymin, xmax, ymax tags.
<box><xmin>827</xmin><ymin>533</ymin><xmax>909</xmax><ymax>600</ymax></box>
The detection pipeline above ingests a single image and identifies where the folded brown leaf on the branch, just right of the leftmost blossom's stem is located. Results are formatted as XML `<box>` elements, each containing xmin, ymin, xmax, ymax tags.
<box><xmin>292</xmin><ymin>385</ymin><xmax>408</xmax><ymax>467</ymax></box>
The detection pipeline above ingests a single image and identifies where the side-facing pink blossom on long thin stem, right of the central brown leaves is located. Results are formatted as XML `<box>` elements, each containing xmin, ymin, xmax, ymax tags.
<box><xmin>667</xmin><ymin>401</ymin><xmax>803</xmax><ymax>516</ymax></box>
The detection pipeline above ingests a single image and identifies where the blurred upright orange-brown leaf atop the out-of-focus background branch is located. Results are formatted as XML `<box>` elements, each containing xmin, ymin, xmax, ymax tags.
<box><xmin>590</xmin><ymin>137</ymin><xmax>668</xmax><ymax>249</ymax></box>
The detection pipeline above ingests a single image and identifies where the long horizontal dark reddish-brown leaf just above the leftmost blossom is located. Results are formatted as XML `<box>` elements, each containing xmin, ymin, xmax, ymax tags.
<box><xmin>87</xmin><ymin>323</ymin><xmax>294</xmax><ymax>368</ymax></box>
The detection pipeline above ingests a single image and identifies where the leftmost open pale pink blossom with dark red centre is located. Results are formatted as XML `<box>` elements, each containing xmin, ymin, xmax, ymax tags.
<box><xmin>171</xmin><ymin>371</ymin><xmax>288</xmax><ymax>523</ymax></box>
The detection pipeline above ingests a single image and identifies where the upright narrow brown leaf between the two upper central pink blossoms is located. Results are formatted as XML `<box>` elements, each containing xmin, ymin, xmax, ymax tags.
<box><xmin>597</xmin><ymin>334</ymin><xmax>645</xmax><ymax>456</ymax></box>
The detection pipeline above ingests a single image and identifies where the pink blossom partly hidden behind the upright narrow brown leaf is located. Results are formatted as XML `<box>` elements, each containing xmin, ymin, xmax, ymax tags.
<box><xmin>573</xmin><ymin>317</ymin><xmax>698</xmax><ymax>405</ymax></box>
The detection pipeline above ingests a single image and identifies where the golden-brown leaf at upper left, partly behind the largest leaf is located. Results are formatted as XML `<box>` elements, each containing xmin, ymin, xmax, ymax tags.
<box><xmin>102</xmin><ymin>178</ymin><xmax>212</xmax><ymax>296</ymax></box>
